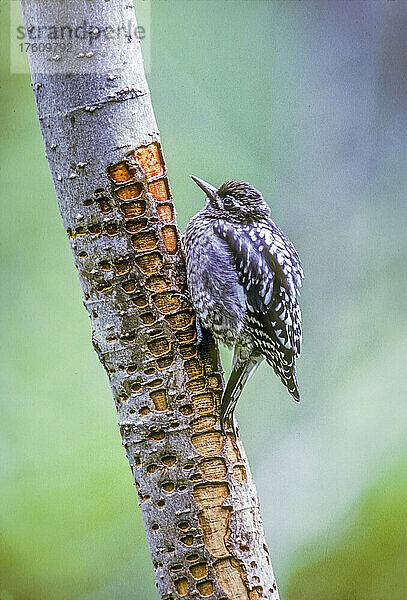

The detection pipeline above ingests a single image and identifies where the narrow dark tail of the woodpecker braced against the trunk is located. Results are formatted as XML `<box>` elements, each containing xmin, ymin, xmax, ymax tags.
<box><xmin>220</xmin><ymin>350</ymin><xmax>263</xmax><ymax>433</ymax></box>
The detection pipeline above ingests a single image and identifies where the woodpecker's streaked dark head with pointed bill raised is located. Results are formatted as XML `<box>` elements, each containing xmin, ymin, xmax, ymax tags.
<box><xmin>191</xmin><ymin>175</ymin><xmax>270</xmax><ymax>223</ymax></box>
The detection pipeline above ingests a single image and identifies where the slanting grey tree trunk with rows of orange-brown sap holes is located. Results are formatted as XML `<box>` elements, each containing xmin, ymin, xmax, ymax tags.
<box><xmin>22</xmin><ymin>0</ymin><xmax>278</xmax><ymax>600</ymax></box>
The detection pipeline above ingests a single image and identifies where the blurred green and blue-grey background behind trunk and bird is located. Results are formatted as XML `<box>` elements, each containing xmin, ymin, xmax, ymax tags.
<box><xmin>0</xmin><ymin>0</ymin><xmax>407</xmax><ymax>600</ymax></box>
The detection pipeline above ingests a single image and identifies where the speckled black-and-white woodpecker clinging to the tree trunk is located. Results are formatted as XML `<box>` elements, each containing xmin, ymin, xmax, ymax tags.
<box><xmin>184</xmin><ymin>175</ymin><xmax>303</xmax><ymax>432</ymax></box>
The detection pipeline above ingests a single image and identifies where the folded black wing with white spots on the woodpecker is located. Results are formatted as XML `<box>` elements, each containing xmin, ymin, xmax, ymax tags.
<box><xmin>214</xmin><ymin>220</ymin><xmax>302</xmax><ymax>400</ymax></box>
